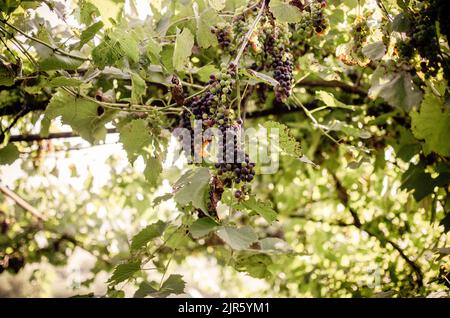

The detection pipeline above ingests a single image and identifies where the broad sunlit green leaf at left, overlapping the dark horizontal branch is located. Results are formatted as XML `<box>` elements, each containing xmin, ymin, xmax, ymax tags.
<box><xmin>44</xmin><ymin>89</ymin><xmax>115</xmax><ymax>143</ymax></box>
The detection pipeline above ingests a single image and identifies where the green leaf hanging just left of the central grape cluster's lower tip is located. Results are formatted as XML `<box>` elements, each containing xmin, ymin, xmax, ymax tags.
<box><xmin>174</xmin><ymin>168</ymin><xmax>211</xmax><ymax>212</ymax></box>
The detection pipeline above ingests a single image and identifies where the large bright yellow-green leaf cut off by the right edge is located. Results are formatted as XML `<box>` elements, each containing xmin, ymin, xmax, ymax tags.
<box><xmin>410</xmin><ymin>93</ymin><xmax>450</xmax><ymax>156</ymax></box>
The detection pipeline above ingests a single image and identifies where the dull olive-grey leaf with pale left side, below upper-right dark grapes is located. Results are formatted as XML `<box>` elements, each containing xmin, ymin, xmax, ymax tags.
<box><xmin>369</xmin><ymin>68</ymin><xmax>422</xmax><ymax>112</ymax></box>
